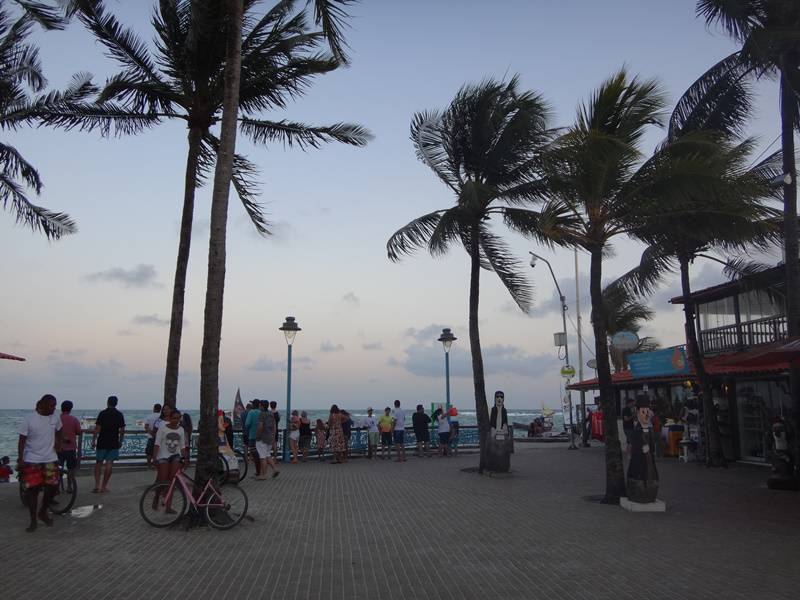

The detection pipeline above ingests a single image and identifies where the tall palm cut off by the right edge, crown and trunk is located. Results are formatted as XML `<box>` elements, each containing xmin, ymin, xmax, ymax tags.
<box><xmin>697</xmin><ymin>0</ymin><xmax>800</xmax><ymax>446</ymax></box>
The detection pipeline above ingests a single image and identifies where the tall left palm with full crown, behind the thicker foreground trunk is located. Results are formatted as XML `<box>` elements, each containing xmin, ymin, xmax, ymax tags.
<box><xmin>51</xmin><ymin>0</ymin><xmax>370</xmax><ymax>406</ymax></box>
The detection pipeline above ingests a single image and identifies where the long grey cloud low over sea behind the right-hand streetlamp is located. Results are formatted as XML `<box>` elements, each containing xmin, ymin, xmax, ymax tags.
<box><xmin>388</xmin><ymin>344</ymin><xmax>559</xmax><ymax>378</ymax></box>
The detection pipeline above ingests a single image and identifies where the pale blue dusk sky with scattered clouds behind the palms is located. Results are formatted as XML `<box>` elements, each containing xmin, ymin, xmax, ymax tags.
<box><xmin>0</xmin><ymin>0</ymin><xmax>779</xmax><ymax>409</ymax></box>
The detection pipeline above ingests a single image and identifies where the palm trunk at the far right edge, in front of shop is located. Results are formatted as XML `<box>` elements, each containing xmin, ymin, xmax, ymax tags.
<box><xmin>781</xmin><ymin>64</ymin><xmax>800</xmax><ymax>463</ymax></box>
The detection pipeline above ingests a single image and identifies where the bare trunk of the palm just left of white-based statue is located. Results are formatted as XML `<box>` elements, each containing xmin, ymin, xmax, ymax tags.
<box><xmin>589</xmin><ymin>248</ymin><xmax>626</xmax><ymax>504</ymax></box>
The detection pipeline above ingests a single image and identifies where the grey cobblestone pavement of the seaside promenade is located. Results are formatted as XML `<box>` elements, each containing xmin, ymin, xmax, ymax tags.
<box><xmin>0</xmin><ymin>444</ymin><xmax>800</xmax><ymax>600</ymax></box>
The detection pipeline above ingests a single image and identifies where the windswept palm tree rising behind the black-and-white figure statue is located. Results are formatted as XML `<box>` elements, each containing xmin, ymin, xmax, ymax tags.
<box><xmin>386</xmin><ymin>77</ymin><xmax>576</xmax><ymax>472</ymax></box>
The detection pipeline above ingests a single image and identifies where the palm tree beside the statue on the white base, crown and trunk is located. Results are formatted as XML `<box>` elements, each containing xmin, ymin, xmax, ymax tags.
<box><xmin>545</xmin><ymin>69</ymin><xmax>665</xmax><ymax>503</ymax></box>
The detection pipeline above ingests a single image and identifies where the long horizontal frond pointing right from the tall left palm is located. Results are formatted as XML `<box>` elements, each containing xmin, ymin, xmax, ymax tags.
<box><xmin>239</xmin><ymin>118</ymin><xmax>372</xmax><ymax>150</ymax></box>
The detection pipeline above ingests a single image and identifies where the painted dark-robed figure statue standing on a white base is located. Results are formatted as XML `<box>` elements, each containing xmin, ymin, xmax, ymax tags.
<box><xmin>628</xmin><ymin>394</ymin><xmax>658</xmax><ymax>503</ymax></box>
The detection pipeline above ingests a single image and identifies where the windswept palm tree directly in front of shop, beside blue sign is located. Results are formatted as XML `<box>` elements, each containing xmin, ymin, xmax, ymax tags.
<box><xmin>609</xmin><ymin>61</ymin><xmax>781</xmax><ymax>466</ymax></box>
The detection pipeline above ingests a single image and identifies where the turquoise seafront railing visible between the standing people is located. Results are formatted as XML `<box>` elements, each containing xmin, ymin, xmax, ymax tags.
<box><xmin>79</xmin><ymin>425</ymin><xmax>526</xmax><ymax>461</ymax></box>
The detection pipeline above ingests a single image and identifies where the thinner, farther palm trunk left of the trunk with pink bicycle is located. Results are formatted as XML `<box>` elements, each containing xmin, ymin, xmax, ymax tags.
<box><xmin>164</xmin><ymin>127</ymin><xmax>203</xmax><ymax>408</ymax></box>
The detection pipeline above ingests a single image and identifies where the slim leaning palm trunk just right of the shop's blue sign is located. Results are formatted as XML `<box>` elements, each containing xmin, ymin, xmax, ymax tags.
<box><xmin>678</xmin><ymin>257</ymin><xmax>725</xmax><ymax>467</ymax></box>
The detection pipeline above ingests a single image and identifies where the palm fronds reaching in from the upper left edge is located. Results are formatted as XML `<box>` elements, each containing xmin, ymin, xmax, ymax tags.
<box><xmin>0</xmin><ymin>0</ymin><xmax>81</xmax><ymax>239</ymax></box>
